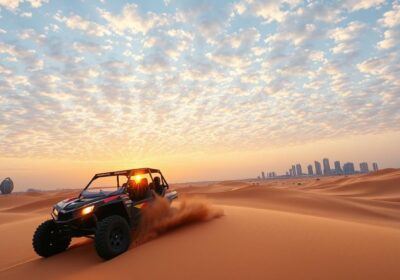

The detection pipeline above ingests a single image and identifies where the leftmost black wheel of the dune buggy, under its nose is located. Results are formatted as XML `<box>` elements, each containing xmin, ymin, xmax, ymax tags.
<box><xmin>32</xmin><ymin>220</ymin><xmax>71</xmax><ymax>258</ymax></box>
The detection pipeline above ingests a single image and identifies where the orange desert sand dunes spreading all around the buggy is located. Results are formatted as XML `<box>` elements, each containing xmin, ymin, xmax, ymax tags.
<box><xmin>0</xmin><ymin>169</ymin><xmax>400</xmax><ymax>279</ymax></box>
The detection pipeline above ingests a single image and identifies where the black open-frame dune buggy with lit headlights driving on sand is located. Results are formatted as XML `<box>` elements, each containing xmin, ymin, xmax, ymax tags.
<box><xmin>32</xmin><ymin>168</ymin><xmax>178</xmax><ymax>259</ymax></box>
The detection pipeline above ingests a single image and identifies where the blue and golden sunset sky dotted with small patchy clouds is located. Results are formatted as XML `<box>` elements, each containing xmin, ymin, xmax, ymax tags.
<box><xmin>0</xmin><ymin>0</ymin><xmax>400</xmax><ymax>190</ymax></box>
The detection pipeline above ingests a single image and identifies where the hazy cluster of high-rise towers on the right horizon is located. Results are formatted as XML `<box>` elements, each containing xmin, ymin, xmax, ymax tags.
<box><xmin>258</xmin><ymin>158</ymin><xmax>379</xmax><ymax>180</ymax></box>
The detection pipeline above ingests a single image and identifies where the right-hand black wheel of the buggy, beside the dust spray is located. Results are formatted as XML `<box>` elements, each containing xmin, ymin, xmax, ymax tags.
<box><xmin>94</xmin><ymin>215</ymin><xmax>131</xmax><ymax>260</ymax></box>
